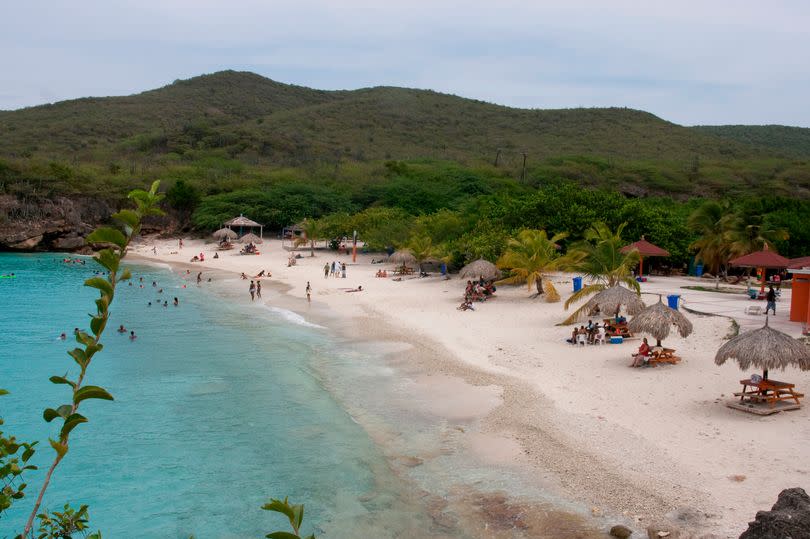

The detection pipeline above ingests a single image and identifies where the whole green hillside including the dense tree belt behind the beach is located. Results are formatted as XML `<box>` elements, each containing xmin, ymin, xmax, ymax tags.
<box><xmin>0</xmin><ymin>71</ymin><xmax>810</xmax><ymax>264</ymax></box>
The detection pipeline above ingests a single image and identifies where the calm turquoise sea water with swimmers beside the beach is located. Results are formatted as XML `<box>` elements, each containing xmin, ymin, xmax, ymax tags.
<box><xmin>0</xmin><ymin>254</ymin><xmax>438</xmax><ymax>539</ymax></box>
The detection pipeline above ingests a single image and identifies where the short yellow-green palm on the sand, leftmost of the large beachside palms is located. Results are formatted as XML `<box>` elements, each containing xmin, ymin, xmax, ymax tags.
<box><xmin>497</xmin><ymin>229</ymin><xmax>568</xmax><ymax>302</ymax></box>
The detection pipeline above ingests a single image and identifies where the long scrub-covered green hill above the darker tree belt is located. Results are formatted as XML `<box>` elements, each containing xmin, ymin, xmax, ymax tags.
<box><xmin>0</xmin><ymin>71</ymin><xmax>810</xmax><ymax>198</ymax></box>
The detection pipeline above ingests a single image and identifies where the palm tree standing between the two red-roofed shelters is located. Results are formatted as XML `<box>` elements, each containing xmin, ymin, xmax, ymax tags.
<box><xmin>686</xmin><ymin>200</ymin><xmax>739</xmax><ymax>287</ymax></box>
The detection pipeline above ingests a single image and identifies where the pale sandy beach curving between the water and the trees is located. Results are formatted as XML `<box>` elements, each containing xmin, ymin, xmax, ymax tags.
<box><xmin>132</xmin><ymin>238</ymin><xmax>810</xmax><ymax>537</ymax></box>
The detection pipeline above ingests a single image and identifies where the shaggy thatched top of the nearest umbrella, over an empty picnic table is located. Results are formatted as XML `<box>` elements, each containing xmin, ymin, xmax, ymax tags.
<box><xmin>714</xmin><ymin>317</ymin><xmax>810</xmax><ymax>379</ymax></box>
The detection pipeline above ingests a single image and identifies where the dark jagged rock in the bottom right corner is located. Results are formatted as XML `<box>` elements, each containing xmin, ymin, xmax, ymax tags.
<box><xmin>740</xmin><ymin>488</ymin><xmax>810</xmax><ymax>539</ymax></box>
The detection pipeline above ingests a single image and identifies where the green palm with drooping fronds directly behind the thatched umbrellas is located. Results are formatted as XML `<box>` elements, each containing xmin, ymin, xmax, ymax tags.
<box><xmin>564</xmin><ymin>222</ymin><xmax>640</xmax><ymax>316</ymax></box>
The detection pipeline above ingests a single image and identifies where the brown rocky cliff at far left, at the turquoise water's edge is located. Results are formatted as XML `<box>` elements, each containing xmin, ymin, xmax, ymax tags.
<box><xmin>0</xmin><ymin>195</ymin><xmax>112</xmax><ymax>251</ymax></box>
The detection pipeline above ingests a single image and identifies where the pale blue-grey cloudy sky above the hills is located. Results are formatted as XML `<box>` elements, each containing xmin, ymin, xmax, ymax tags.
<box><xmin>0</xmin><ymin>0</ymin><xmax>810</xmax><ymax>127</ymax></box>
